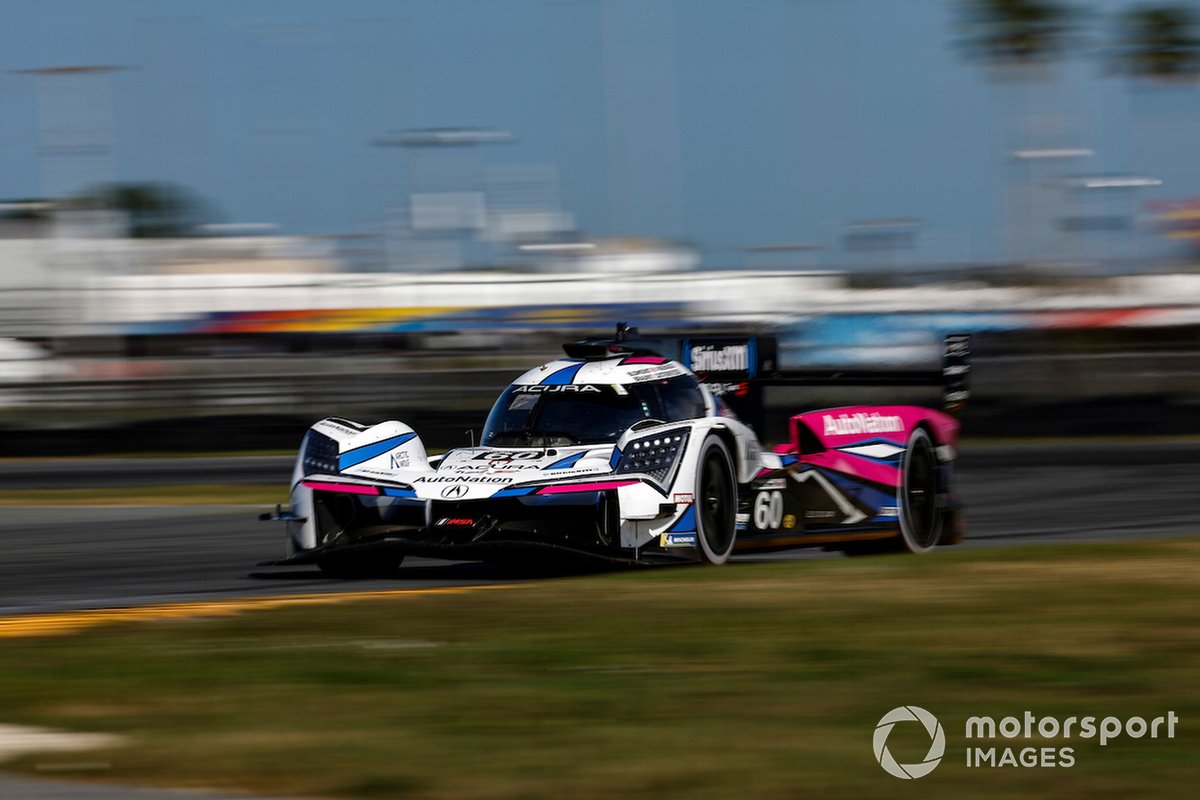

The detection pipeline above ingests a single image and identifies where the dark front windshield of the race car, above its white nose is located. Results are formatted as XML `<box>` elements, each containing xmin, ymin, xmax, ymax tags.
<box><xmin>482</xmin><ymin>384</ymin><xmax>661</xmax><ymax>447</ymax></box>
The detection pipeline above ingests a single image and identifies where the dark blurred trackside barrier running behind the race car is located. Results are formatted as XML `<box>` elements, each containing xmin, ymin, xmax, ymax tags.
<box><xmin>0</xmin><ymin>345</ymin><xmax>1200</xmax><ymax>456</ymax></box>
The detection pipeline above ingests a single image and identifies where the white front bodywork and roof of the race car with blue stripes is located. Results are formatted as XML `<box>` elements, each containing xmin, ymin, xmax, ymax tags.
<box><xmin>289</xmin><ymin>357</ymin><xmax>762</xmax><ymax>554</ymax></box>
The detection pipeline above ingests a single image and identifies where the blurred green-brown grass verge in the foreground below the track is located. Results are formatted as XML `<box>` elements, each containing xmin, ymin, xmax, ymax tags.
<box><xmin>0</xmin><ymin>540</ymin><xmax>1200</xmax><ymax>800</ymax></box>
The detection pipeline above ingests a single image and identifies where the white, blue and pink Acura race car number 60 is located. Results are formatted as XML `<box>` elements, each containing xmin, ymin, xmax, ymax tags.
<box><xmin>264</xmin><ymin>325</ymin><xmax>968</xmax><ymax>576</ymax></box>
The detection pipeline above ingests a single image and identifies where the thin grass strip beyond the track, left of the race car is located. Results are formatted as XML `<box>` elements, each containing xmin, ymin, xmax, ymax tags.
<box><xmin>0</xmin><ymin>483</ymin><xmax>279</xmax><ymax>506</ymax></box>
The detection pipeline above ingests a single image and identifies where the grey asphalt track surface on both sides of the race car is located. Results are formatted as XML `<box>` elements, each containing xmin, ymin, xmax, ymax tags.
<box><xmin>0</xmin><ymin>443</ymin><xmax>1200</xmax><ymax>614</ymax></box>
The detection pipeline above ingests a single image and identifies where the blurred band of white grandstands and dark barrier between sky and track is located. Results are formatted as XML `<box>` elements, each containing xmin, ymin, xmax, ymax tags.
<box><xmin>0</xmin><ymin>221</ymin><xmax>1200</xmax><ymax>455</ymax></box>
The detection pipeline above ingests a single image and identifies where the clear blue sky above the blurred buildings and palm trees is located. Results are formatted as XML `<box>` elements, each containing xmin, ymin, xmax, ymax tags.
<box><xmin>0</xmin><ymin>0</ymin><xmax>1200</xmax><ymax>265</ymax></box>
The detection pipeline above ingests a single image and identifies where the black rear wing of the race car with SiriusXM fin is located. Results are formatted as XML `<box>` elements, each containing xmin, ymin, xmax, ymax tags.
<box><xmin>678</xmin><ymin>333</ymin><xmax>971</xmax><ymax>422</ymax></box>
